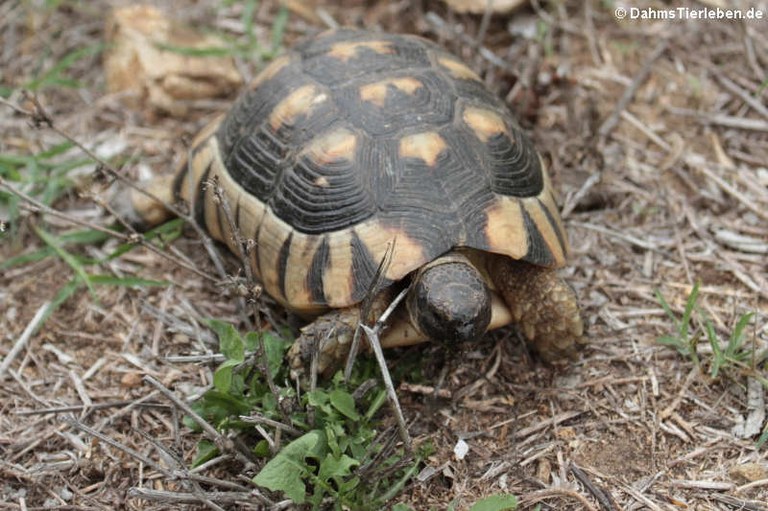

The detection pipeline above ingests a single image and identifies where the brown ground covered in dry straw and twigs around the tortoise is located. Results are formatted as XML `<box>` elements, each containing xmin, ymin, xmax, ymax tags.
<box><xmin>0</xmin><ymin>0</ymin><xmax>768</xmax><ymax>510</ymax></box>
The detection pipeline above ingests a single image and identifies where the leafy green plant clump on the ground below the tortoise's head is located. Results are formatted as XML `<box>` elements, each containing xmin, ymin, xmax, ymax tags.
<box><xmin>185</xmin><ymin>320</ymin><xmax>428</xmax><ymax>509</ymax></box>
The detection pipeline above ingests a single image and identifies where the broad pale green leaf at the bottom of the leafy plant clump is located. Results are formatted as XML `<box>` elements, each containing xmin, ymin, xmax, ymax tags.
<box><xmin>253</xmin><ymin>430</ymin><xmax>326</xmax><ymax>504</ymax></box>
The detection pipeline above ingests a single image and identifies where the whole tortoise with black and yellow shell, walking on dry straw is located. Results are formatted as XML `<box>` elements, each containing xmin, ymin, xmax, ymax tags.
<box><xmin>123</xmin><ymin>29</ymin><xmax>584</xmax><ymax>370</ymax></box>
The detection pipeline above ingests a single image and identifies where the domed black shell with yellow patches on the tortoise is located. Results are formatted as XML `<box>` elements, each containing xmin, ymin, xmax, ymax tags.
<box><xmin>175</xmin><ymin>30</ymin><xmax>567</xmax><ymax>313</ymax></box>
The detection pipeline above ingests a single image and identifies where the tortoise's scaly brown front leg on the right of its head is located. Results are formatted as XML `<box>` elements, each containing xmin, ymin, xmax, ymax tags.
<box><xmin>489</xmin><ymin>256</ymin><xmax>586</xmax><ymax>362</ymax></box>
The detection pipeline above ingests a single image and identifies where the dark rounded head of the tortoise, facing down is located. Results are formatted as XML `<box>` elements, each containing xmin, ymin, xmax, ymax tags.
<box><xmin>407</xmin><ymin>253</ymin><xmax>491</xmax><ymax>344</ymax></box>
